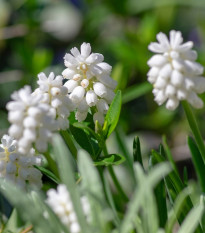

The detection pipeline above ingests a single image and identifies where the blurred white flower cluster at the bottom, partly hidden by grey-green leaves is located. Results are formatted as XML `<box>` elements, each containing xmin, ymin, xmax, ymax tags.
<box><xmin>46</xmin><ymin>184</ymin><xmax>90</xmax><ymax>233</ymax></box>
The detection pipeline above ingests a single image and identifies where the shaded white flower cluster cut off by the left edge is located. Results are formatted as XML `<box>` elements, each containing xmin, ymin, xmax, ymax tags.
<box><xmin>0</xmin><ymin>135</ymin><xmax>42</xmax><ymax>188</ymax></box>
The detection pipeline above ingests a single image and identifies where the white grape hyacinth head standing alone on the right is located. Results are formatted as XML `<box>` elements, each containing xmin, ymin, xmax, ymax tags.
<box><xmin>148</xmin><ymin>30</ymin><xmax>205</xmax><ymax>110</ymax></box>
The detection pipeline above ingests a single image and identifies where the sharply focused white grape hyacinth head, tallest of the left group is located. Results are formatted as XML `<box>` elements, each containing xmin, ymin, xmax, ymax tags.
<box><xmin>62</xmin><ymin>43</ymin><xmax>117</xmax><ymax>125</ymax></box>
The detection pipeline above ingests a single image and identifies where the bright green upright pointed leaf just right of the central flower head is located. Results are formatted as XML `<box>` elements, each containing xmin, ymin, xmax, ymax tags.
<box><xmin>103</xmin><ymin>90</ymin><xmax>122</xmax><ymax>138</ymax></box>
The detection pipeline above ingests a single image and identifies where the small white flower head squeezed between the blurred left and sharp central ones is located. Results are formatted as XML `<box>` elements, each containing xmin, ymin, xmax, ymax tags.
<box><xmin>34</xmin><ymin>72</ymin><xmax>74</xmax><ymax>130</ymax></box>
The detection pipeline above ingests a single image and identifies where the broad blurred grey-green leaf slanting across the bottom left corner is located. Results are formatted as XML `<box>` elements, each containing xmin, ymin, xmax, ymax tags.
<box><xmin>0</xmin><ymin>180</ymin><xmax>69</xmax><ymax>233</ymax></box>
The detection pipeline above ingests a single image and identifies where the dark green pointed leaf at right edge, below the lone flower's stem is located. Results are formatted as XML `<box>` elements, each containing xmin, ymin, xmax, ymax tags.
<box><xmin>188</xmin><ymin>137</ymin><xmax>205</xmax><ymax>192</ymax></box>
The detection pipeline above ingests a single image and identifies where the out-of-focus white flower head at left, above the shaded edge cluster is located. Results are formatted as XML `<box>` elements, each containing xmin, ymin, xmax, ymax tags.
<box><xmin>6</xmin><ymin>86</ymin><xmax>56</xmax><ymax>154</ymax></box>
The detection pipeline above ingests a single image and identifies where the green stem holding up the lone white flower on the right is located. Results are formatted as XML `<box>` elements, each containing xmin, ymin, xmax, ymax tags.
<box><xmin>182</xmin><ymin>101</ymin><xmax>205</xmax><ymax>162</ymax></box>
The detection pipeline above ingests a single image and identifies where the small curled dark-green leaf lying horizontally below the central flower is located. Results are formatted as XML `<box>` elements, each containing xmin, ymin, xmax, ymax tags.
<box><xmin>94</xmin><ymin>154</ymin><xmax>125</xmax><ymax>166</ymax></box>
